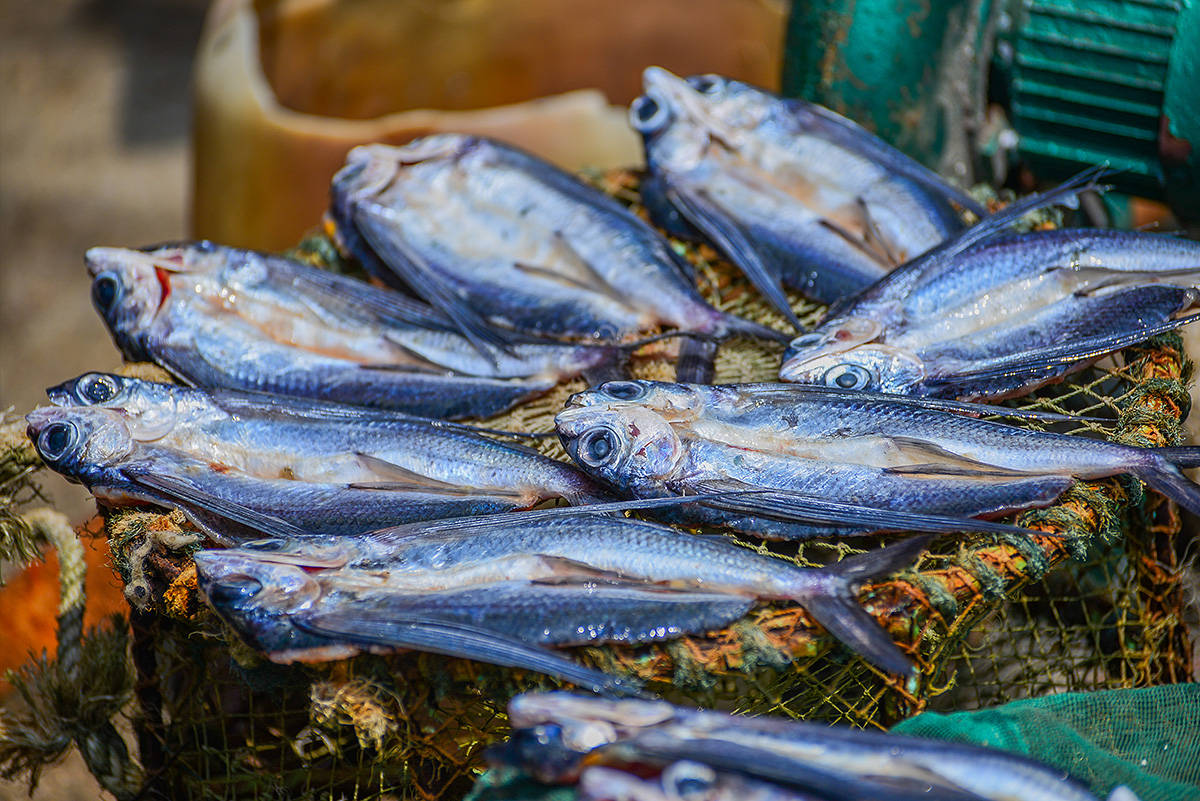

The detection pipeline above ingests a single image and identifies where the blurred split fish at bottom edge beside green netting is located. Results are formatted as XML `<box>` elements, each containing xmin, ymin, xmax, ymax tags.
<box><xmin>493</xmin><ymin>692</ymin><xmax>1096</xmax><ymax>801</ymax></box>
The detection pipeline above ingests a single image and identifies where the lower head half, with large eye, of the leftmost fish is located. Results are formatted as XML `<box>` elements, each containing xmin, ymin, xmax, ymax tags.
<box><xmin>25</xmin><ymin>406</ymin><xmax>136</xmax><ymax>487</ymax></box>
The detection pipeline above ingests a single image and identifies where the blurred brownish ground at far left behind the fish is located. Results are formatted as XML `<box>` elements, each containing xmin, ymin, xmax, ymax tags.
<box><xmin>0</xmin><ymin>0</ymin><xmax>205</xmax><ymax>801</ymax></box>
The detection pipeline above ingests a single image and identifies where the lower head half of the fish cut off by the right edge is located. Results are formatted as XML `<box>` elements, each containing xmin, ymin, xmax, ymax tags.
<box><xmin>779</xmin><ymin>343</ymin><xmax>925</xmax><ymax>393</ymax></box>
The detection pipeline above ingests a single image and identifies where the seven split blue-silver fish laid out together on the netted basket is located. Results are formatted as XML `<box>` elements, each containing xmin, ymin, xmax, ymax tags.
<box><xmin>28</xmin><ymin>67</ymin><xmax>1200</xmax><ymax>700</ymax></box>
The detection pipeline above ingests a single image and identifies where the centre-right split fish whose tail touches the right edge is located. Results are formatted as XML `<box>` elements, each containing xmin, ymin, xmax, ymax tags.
<box><xmin>556</xmin><ymin>381</ymin><xmax>1200</xmax><ymax>538</ymax></box>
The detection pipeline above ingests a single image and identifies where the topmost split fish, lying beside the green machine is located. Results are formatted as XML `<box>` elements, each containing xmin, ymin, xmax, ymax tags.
<box><xmin>629</xmin><ymin>67</ymin><xmax>984</xmax><ymax>321</ymax></box>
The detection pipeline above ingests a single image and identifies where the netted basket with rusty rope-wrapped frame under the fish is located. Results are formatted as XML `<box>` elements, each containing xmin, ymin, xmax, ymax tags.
<box><xmin>0</xmin><ymin>173</ymin><xmax>1194</xmax><ymax>800</ymax></box>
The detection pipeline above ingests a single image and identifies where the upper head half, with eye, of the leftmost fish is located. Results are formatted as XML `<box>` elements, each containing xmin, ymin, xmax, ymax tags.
<box><xmin>46</xmin><ymin>373</ymin><xmax>178</xmax><ymax>441</ymax></box>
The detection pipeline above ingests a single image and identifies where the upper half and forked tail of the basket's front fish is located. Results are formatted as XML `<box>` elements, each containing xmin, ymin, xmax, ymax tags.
<box><xmin>225</xmin><ymin>507</ymin><xmax>929</xmax><ymax>675</ymax></box>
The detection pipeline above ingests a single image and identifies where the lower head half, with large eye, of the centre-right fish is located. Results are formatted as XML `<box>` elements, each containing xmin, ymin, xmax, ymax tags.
<box><xmin>554</xmin><ymin>404</ymin><xmax>684</xmax><ymax>489</ymax></box>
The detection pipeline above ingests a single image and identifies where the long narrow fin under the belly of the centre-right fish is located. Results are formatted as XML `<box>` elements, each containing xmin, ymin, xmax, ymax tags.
<box><xmin>696</xmin><ymin>480</ymin><xmax>1045</xmax><ymax>536</ymax></box>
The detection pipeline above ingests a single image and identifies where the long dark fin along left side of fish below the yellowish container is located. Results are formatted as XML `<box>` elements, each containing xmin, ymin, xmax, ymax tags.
<box><xmin>355</xmin><ymin>200</ymin><xmax>510</xmax><ymax>361</ymax></box>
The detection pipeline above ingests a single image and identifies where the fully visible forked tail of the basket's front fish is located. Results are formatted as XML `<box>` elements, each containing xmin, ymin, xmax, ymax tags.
<box><xmin>798</xmin><ymin>537</ymin><xmax>931</xmax><ymax>675</ymax></box>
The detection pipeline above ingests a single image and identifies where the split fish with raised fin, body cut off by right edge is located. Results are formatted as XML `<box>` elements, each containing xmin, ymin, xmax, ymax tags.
<box><xmin>779</xmin><ymin>174</ymin><xmax>1200</xmax><ymax>399</ymax></box>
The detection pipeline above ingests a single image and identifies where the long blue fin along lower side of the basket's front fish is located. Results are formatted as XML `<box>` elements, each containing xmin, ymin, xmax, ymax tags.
<box><xmin>292</xmin><ymin>609</ymin><xmax>642</xmax><ymax>695</ymax></box>
